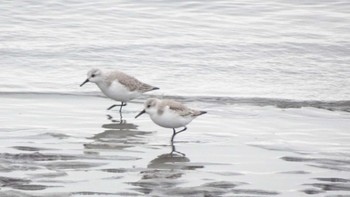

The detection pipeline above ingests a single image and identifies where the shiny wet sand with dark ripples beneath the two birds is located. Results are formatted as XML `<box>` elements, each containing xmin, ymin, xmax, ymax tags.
<box><xmin>0</xmin><ymin>93</ymin><xmax>350</xmax><ymax>196</ymax></box>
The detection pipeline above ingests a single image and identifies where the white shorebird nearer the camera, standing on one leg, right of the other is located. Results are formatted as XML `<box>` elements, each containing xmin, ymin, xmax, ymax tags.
<box><xmin>135</xmin><ymin>98</ymin><xmax>207</xmax><ymax>142</ymax></box>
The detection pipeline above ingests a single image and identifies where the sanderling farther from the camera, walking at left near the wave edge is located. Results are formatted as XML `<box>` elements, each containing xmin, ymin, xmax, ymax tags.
<box><xmin>80</xmin><ymin>69</ymin><xmax>159</xmax><ymax>112</ymax></box>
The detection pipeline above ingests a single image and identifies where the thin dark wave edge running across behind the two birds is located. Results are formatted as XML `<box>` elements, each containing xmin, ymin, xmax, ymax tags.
<box><xmin>0</xmin><ymin>92</ymin><xmax>350</xmax><ymax>112</ymax></box>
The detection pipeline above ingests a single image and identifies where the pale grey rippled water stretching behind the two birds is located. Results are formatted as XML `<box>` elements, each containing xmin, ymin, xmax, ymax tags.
<box><xmin>0</xmin><ymin>0</ymin><xmax>350</xmax><ymax>101</ymax></box>
